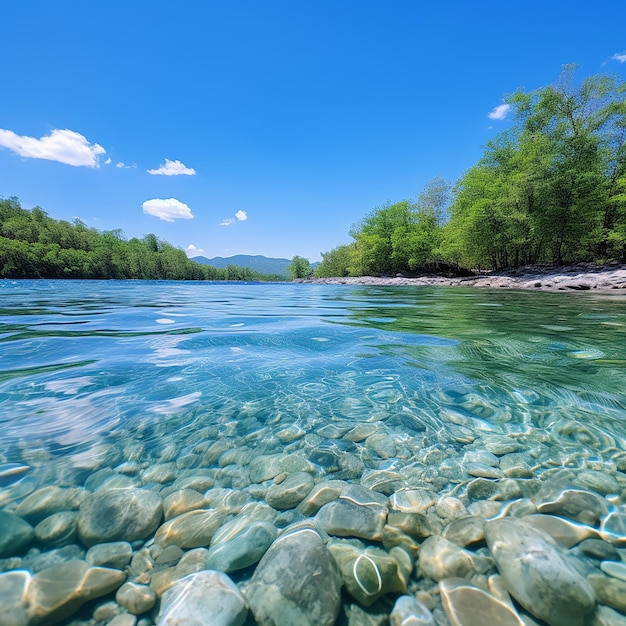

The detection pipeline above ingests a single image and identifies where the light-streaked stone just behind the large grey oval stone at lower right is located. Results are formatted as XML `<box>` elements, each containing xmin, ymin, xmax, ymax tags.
<box><xmin>534</xmin><ymin>482</ymin><xmax>608</xmax><ymax>526</ymax></box>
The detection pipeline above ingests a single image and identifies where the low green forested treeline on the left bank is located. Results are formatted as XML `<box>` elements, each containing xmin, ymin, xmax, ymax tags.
<box><xmin>0</xmin><ymin>198</ymin><xmax>277</xmax><ymax>281</ymax></box>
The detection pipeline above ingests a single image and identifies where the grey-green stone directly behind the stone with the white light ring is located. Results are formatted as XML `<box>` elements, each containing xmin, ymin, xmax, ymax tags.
<box><xmin>315</xmin><ymin>485</ymin><xmax>388</xmax><ymax>541</ymax></box>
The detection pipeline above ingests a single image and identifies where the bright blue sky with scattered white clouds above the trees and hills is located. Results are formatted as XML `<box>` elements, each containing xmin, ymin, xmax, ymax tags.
<box><xmin>0</xmin><ymin>0</ymin><xmax>626</xmax><ymax>261</ymax></box>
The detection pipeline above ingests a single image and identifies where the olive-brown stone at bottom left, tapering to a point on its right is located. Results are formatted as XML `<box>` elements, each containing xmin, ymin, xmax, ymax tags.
<box><xmin>28</xmin><ymin>560</ymin><xmax>126</xmax><ymax>624</ymax></box>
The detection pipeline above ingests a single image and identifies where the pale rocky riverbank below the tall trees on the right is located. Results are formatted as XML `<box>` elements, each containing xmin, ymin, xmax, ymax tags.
<box><xmin>301</xmin><ymin>263</ymin><xmax>626</xmax><ymax>291</ymax></box>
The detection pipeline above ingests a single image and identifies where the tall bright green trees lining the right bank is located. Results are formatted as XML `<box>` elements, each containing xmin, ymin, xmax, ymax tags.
<box><xmin>315</xmin><ymin>66</ymin><xmax>626</xmax><ymax>277</ymax></box>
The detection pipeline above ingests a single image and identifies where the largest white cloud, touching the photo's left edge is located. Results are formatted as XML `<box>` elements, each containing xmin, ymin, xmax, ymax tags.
<box><xmin>0</xmin><ymin>128</ymin><xmax>106</xmax><ymax>167</ymax></box>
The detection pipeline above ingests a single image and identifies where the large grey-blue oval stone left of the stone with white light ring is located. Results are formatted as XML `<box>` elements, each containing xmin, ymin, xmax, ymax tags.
<box><xmin>246</xmin><ymin>528</ymin><xmax>341</xmax><ymax>626</ymax></box>
